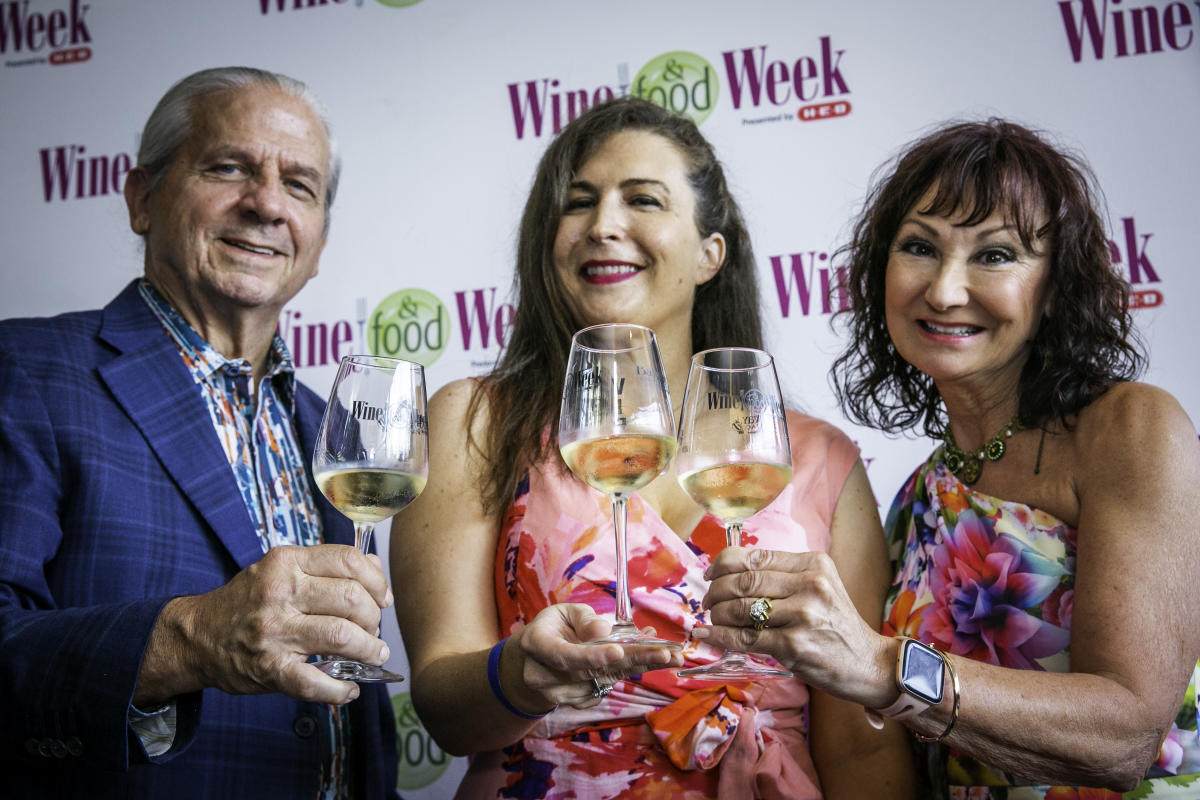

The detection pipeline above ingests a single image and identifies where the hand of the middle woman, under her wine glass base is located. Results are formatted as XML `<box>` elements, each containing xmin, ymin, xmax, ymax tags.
<box><xmin>500</xmin><ymin>603</ymin><xmax>683</xmax><ymax>712</ymax></box>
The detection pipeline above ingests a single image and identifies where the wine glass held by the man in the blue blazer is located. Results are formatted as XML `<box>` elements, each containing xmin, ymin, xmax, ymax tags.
<box><xmin>312</xmin><ymin>355</ymin><xmax>428</xmax><ymax>684</ymax></box>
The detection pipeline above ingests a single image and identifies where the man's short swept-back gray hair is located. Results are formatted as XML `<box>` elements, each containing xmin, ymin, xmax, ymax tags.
<box><xmin>138</xmin><ymin>67</ymin><xmax>342</xmax><ymax>234</ymax></box>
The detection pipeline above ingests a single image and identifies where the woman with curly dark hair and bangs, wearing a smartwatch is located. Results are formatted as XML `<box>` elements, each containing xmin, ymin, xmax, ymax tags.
<box><xmin>694</xmin><ymin>120</ymin><xmax>1200</xmax><ymax>800</ymax></box>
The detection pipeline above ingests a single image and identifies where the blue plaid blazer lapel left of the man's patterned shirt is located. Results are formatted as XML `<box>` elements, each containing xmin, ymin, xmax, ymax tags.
<box><xmin>100</xmin><ymin>281</ymin><xmax>263</xmax><ymax>570</ymax></box>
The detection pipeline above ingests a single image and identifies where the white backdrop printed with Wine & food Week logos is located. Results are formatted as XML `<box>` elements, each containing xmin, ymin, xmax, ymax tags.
<box><xmin>0</xmin><ymin>0</ymin><xmax>1200</xmax><ymax>798</ymax></box>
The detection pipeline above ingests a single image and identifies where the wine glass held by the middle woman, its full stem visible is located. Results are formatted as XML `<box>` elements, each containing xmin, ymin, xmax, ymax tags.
<box><xmin>558</xmin><ymin>324</ymin><xmax>683</xmax><ymax>648</ymax></box>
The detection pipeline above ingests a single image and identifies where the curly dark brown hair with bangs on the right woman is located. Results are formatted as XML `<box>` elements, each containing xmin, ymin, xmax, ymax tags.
<box><xmin>830</xmin><ymin>119</ymin><xmax>1145</xmax><ymax>437</ymax></box>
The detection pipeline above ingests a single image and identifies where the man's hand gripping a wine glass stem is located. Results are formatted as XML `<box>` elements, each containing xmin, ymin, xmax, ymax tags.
<box><xmin>134</xmin><ymin>545</ymin><xmax>392</xmax><ymax>704</ymax></box>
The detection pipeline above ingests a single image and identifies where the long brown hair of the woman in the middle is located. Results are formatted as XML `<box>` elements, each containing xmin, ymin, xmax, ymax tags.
<box><xmin>468</xmin><ymin>98</ymin><xmax>762</xmax><ymax>513</ymax></box>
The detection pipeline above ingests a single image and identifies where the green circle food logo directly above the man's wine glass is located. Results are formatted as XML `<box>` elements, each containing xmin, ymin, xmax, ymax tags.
<box><xmin>367</xmin><ymin>289</ymin><xmax>450</xmax><ymax>367</ymax></box>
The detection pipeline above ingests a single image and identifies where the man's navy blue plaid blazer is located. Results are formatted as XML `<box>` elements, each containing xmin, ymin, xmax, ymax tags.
<box><xmin>0</xmin><ymin>282</ymin><xmax>396</xmax><ymax>800</ymax></box>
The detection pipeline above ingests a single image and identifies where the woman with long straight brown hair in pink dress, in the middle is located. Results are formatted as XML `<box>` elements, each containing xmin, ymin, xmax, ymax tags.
<box><xmin>389</xmin><ymin>98</ymin><xmax>913</xmax><ymax>800</ymax></box>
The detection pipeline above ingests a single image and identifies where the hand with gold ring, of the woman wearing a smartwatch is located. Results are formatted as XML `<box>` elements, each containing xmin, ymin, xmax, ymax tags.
<box><xmin>692</xmin><ymin>547</ymin><xmax>895</xmax><ymax>708</ymax></box>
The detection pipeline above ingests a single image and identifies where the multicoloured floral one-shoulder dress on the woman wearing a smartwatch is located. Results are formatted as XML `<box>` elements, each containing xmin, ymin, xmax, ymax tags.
<box><xmin>884</xmin><ymin>450</ymin><xmax>1200</xmax><ymax>800</ymax></box>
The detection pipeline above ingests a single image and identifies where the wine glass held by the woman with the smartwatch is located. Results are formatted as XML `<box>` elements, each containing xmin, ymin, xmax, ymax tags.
<box><xmin>676</xmin><ymin>348</ymin><xmax>792</xmax><ymax>680</ymax></box>
